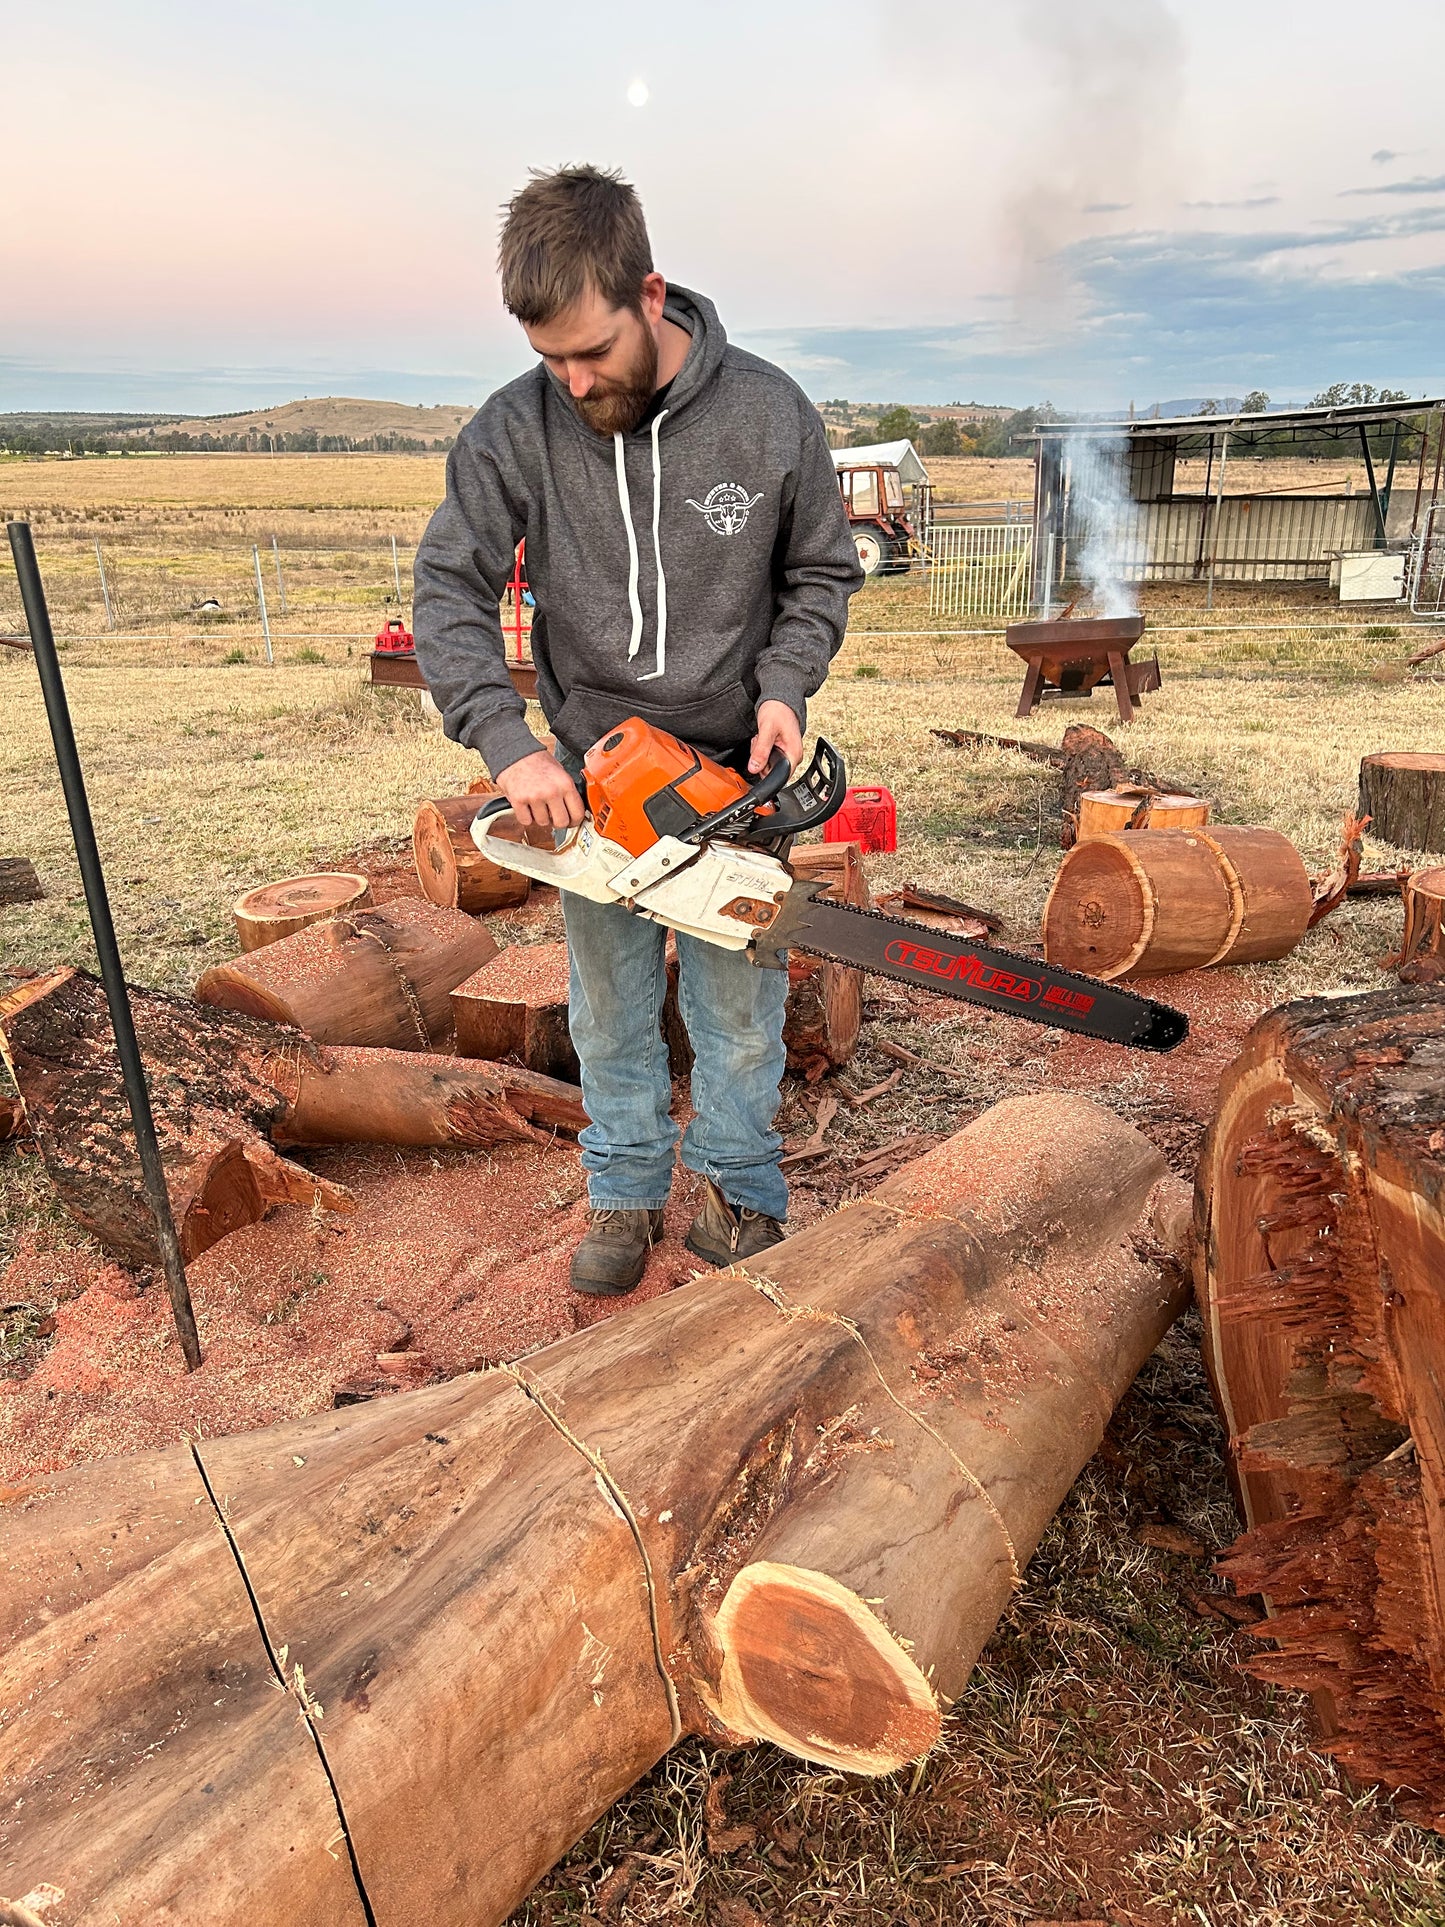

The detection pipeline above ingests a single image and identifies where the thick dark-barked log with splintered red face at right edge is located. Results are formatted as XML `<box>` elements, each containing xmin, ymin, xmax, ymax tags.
<box><xmin>1195</xmin><ymin>987</ymin><xmax>1445</xmax><ymax>1827</ymax></box>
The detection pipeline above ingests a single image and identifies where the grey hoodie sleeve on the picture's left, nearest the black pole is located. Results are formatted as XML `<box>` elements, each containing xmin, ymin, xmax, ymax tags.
<box><xmin>412</xmin><ymin>436</ymin><xmax>541</xmax><ymax>777</ymax></box>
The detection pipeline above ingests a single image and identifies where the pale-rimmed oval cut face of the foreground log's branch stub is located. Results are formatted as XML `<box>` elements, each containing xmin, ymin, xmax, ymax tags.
<box><xmin>713</xmin><ymin>1561</ymin><xmax>942</xmax><ymax>1775</ymax></box>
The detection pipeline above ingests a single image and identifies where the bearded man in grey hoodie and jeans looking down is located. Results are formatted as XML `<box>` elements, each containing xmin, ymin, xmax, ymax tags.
<box><xmin>414</xmin><ymin>168</ymin><xmax>863</xmax><ymax>1293</ymax></box>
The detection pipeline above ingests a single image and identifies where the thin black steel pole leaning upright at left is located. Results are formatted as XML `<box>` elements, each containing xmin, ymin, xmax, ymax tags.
<box><xmin>6</xmin><ymin>522</ymin><xmax>200</xmax><ymax>1372</ymax></box>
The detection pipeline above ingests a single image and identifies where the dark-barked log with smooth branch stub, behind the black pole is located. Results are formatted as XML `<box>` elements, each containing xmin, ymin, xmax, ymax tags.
<box><xmin>0</xmin><ymin>969</ymin><xmax>586</xmax><ymax>1266</ymax></box>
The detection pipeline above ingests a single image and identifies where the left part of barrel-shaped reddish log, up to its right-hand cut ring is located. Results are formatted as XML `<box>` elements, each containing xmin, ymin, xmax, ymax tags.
<box><xmin>1044</xmin><ymin>831</ymin><xmax>1239</xmax><ymax>983</ymax></box>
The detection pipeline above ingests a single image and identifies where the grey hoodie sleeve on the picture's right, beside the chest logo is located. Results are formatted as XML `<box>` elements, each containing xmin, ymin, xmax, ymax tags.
<box><xmin>757</xmin><ymin>395</ymin><xmax>863</xmax><ymax>728</ymax></box>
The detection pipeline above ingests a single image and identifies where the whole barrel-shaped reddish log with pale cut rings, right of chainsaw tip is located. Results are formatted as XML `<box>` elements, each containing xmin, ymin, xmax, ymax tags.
<box><xmin>1044</xmin><ymin>827</ymin><xmax>1314</xmax><ymax>983</ymax></box>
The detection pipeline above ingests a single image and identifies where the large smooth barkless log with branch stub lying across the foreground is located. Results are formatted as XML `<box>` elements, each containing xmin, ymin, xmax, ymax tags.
<box><xmin>0</xmin><ymin>1096</ymin><xmax>1183</xmax><ymax>1927</ymax></box>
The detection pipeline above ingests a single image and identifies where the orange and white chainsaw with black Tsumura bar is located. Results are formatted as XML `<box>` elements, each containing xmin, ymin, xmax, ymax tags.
<box><xmin>472</xmin><ymin>717</ymin><xmax>1189</xmax><ymax>1050</ymax></box>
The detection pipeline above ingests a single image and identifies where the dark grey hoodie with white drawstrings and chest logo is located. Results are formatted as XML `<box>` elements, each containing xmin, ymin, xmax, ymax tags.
<box><xmin>414</xmin><ymin>287</ymin><xmax>863</xmax><ymax>777</ymax></box>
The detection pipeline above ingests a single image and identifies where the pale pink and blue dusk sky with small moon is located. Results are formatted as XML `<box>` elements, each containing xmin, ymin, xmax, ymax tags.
<box><xmin>0</xmin><ymin>0</ymin><xmax>1445</xmax><ymax>412</ymax></box>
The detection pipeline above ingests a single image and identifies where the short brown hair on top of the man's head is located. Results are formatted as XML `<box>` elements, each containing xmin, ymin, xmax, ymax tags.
<box><xmin>497</xmin><ymin>168</ymin><xmax>653</xmax><ymax>328</ymax></box>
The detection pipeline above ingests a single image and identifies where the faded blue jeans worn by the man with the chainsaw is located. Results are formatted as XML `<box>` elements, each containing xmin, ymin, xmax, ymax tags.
<box><xmin>563</xmin><ymin>890</ymin><xmax>788</xmax><ymax>1218</ymax></box>
